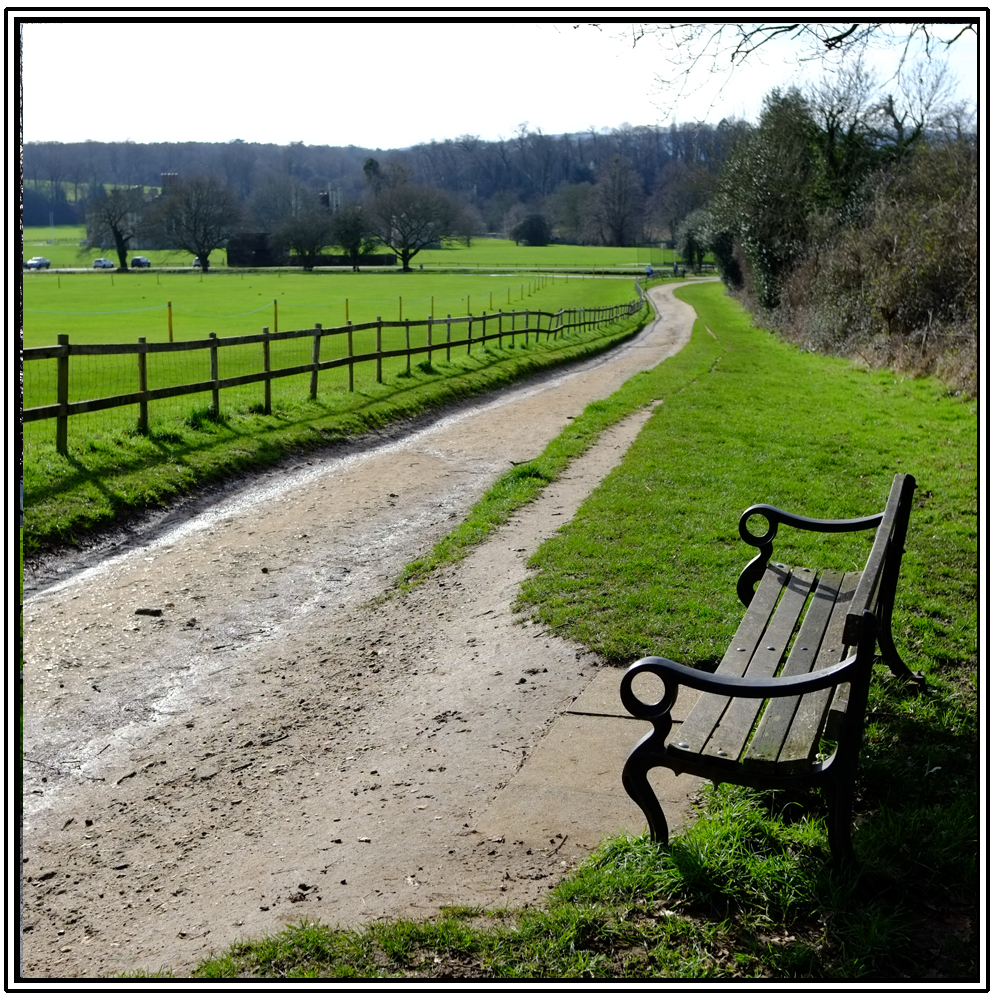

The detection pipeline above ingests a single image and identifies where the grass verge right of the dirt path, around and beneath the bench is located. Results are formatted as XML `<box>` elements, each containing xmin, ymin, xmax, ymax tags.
<box><xmin>145</xmin><ymin>285</ymin><xmax>981</xmax><ymax>982</ymax></box>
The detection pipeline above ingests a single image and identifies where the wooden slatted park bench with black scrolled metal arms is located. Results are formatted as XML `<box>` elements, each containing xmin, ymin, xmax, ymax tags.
<box><xmin>621</xmin><ymin>475</ymin><xmax>923</xmax><ymax>860</ymax></box>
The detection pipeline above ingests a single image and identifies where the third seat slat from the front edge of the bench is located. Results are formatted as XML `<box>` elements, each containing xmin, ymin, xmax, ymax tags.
<box><xmin>743</xmin><ymin>572</ymin><xmax>846</xmax><ymax>773</ymax></box>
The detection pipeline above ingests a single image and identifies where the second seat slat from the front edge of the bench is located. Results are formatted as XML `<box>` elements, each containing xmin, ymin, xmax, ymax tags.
<box><xmin>704</xmin><ymin>569</ymin><xmax>816</xmax><ymax>760</ymax></box>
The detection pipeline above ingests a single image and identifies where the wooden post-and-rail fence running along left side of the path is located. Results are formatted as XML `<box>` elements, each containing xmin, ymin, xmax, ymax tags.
<box><xmin>21</xmin><ymin>294</ymin><xmax>643</xmax><ymax>454</ymax></box>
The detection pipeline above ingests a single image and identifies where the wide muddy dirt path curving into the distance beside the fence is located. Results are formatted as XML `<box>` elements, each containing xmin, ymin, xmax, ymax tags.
<box><xmin>22</xmin><ymin>288</ymin><xmax>694</xmax><ymax>978</ymax></box>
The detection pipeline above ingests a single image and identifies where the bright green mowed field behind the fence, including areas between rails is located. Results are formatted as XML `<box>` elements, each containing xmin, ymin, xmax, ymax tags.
<box><xmin>24</xmin><ymin>270</ymin><xmax>648</xmax><ymax>447</ymax></box>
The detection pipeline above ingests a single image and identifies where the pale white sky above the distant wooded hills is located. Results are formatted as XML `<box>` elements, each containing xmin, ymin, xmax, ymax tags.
<box><xmin>15</xmin><ymin>11</ymin><xmax>978</xmax><ymax>149</ymax></box>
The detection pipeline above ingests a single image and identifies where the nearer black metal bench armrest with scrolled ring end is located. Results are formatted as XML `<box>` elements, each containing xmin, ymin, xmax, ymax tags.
<box><xmin>621</xmin><ymin>654</ymin><xmax>857</xmax><ymax>719</ymax></box>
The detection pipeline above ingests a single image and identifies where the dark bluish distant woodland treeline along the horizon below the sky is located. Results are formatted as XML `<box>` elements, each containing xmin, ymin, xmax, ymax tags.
<box><xmin>23</xmin><ymin>121</ymin><xmax>748</xmax><ymax>243</ymax></box>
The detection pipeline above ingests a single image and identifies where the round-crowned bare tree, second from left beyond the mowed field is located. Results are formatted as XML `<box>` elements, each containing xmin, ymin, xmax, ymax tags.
<box><xmin>155</xmin><ymin>177</ymin><xmax>242</xmax><ymax>271</ymax></box>
